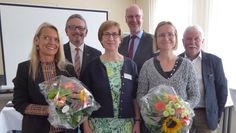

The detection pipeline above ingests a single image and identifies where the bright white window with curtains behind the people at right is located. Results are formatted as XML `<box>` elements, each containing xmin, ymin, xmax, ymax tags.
<box><xmin>149</xmin><ymin>0</ymin><xmax>236</xmax><ymax>89</ymax></box>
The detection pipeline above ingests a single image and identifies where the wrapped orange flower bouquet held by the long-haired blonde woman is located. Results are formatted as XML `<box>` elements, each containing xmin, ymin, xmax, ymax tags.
<box><xmin>39</xmin><ymin>76</ymin><xmax>100</xmax><ymax>129</ymax></box>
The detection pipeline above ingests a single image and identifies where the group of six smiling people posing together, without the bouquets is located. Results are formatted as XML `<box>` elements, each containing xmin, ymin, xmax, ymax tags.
<box><xmin>13</xmin><ymin>4</ymin><xmax>227</xmax><ymax>133</ymax></box>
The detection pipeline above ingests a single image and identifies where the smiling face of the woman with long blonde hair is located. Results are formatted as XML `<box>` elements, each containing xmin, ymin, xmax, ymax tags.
<box><xmin>35</xmin><ymin>27</ymin><xmax>60</xmax><ymax>58</ymax></box>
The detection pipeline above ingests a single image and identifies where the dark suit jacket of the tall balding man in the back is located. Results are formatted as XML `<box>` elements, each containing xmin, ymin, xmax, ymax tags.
<box><xmin>119</xmin><ymin>32</ymin><xmax>154</xmax><ymax>72</ymax></box>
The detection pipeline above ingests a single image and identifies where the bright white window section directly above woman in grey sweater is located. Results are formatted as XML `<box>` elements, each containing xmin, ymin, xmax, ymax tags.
<box><xmin>149</xmin><ymin>0</ymin><xmax>192</xmax><ymax>54</ymax></box>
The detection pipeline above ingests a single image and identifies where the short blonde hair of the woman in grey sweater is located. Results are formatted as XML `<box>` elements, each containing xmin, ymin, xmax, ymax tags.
<box><xmin>153</xmin><ymin>21</ymin><xmax>178</xmax><ymax>53</ymax></box>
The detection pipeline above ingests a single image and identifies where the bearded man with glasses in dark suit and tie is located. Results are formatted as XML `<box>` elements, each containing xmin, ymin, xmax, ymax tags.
<box><xmin>64</xmin><ymin>14</ymin><xmax>101</xmax><ymax>133</ymax></box>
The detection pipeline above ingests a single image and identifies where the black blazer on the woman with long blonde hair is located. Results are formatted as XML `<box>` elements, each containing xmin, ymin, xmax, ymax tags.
<box><xmin>13</xmin><ymin>61</ymin><xmax>76</xmax><ymax>133</ymax></box>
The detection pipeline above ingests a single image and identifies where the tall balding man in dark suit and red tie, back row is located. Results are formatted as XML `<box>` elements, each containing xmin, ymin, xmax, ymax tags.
<box><xmin>119</xmin><ymin>4</ymin><xmax>153</xmax><ymax>72</ymax></box>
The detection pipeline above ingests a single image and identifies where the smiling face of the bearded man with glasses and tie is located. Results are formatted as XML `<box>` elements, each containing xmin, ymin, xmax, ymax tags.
<box><xmin>65</xmin><ymin>18</ymin><xmax>87</xmax><ymax>46</ymax></box>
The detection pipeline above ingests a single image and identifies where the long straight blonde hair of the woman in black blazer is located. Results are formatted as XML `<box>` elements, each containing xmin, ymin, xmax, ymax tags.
<box><xmin>29</xmin><ymin>22</ymin><xmax>67</xmax><ymax>80</ymax></box>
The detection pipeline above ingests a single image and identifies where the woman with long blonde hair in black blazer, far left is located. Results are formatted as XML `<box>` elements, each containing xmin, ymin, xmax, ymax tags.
<box><xmin>13</xmin><ymin>23</ymin><xmax>76</xmax><ymax>133</ymax></box>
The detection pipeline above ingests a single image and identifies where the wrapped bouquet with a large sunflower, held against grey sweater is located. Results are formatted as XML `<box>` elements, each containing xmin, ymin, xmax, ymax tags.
<box><xmin>140</xmin><ymin>85</ymin><xmax>194</xmax><ymax>133</ymax></box>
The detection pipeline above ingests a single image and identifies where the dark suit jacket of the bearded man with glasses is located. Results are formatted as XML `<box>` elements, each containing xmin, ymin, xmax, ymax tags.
<box><xmin>64</xmin><ymin>42</ymin><xmax>101</xmax><ymax>78</ymax></box>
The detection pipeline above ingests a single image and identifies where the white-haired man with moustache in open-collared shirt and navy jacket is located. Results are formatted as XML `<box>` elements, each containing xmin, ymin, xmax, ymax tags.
<box><xmin>180</xmin><ymin>26</ymin><xmax>228</xmax><ymax>133</ymax></box>
